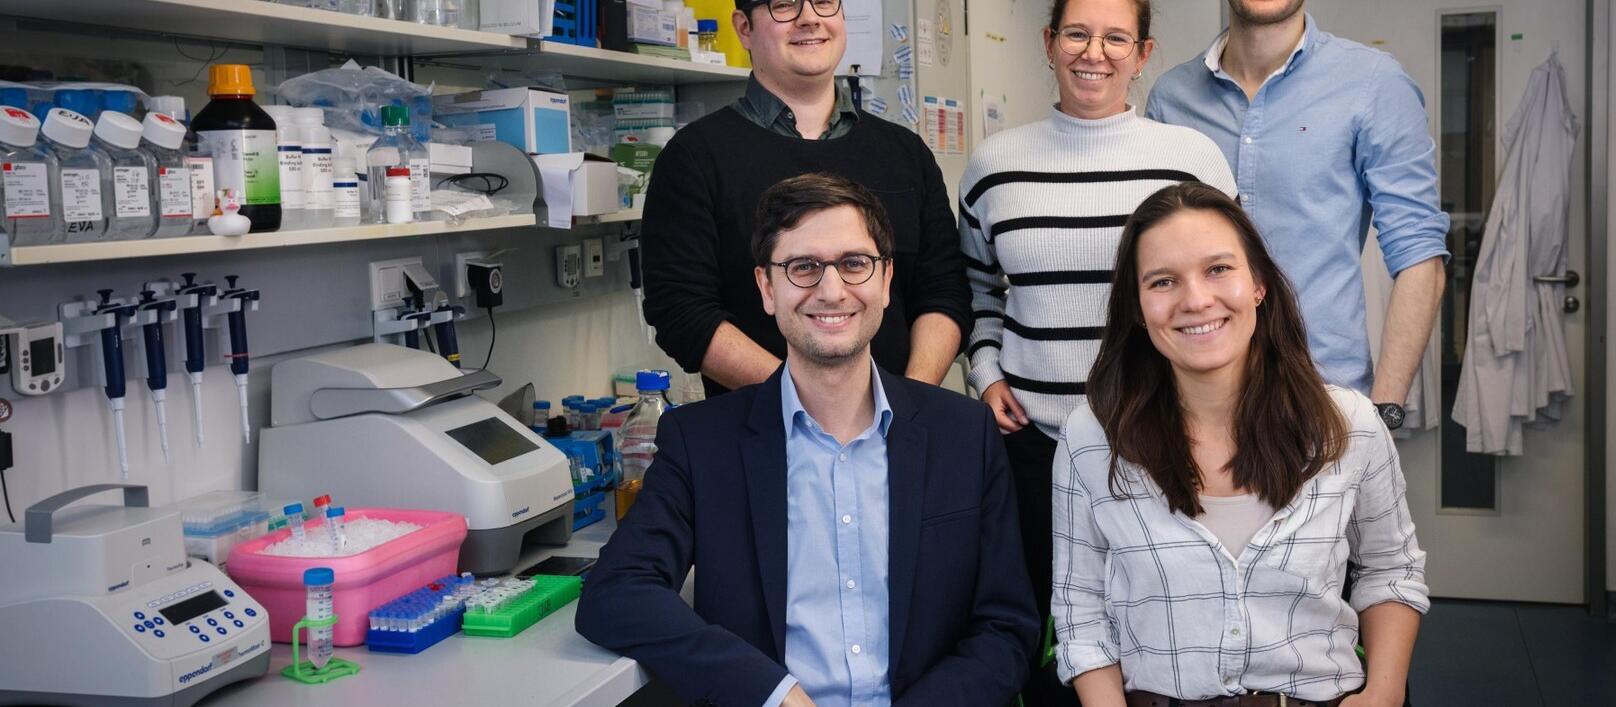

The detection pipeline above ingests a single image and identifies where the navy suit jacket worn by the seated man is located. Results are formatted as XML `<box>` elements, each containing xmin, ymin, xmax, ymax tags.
<box><xmin>577</xmin><ymin>371</ymin><xmax>1049</xmax><ymax>707</ymax></box>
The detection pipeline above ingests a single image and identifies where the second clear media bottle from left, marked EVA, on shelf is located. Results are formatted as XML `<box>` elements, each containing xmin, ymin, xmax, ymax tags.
<box><xmin>39</xmin><ymin>108</ymin><xmax>112</xmax><ymax>242</ymax></box>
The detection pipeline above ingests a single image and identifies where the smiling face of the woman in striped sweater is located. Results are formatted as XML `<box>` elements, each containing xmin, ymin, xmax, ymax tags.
<box><xmin>1044</xmin><ymin>0</ymin><xmax>1155</xmax><ymax>119</ymax></box>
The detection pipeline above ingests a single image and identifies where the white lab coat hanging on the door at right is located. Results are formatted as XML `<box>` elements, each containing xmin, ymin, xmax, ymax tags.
<box><xmin>1453</xmin><ymin>53</ymin><xmax>1577</xmax><ymax>455</ymax></box>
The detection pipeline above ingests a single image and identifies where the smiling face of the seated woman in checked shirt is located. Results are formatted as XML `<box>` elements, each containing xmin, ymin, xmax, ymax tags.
<box><xmin>1138</xmin><ymin>208</ymin><xmax>1267</xmax><ymax>376</ymax></box>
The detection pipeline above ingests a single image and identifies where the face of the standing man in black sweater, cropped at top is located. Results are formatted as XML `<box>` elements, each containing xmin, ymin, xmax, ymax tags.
<box><xmin>732</xmin><ymin>3</ymin><xmax>847</xmax><ymax>86</ymax></box>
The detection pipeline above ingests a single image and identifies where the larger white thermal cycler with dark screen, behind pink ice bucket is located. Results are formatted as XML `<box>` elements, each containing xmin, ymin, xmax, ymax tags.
<box><xmin>259</xmin><ymin>344</ymin><xmax>572</xmax><ymax>575</ymax></box>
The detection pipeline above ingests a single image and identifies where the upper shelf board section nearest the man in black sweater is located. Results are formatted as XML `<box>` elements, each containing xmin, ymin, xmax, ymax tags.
<box><xmin>427</xmin><ymin>40</ymin><xmax>751</xmax><ymax>86</ymax></box>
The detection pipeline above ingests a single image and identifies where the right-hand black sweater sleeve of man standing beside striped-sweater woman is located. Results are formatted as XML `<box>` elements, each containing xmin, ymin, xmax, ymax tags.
<box><xmin>900</xmin><ymin>129</ymin><xmax>971</xmax><ymax>347</ymax></box>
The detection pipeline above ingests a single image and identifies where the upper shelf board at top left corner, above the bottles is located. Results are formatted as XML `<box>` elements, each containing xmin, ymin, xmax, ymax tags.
<box><xmin>0</xmin><ymin>0</ymin><xmax>528</xmax><ymax>56</ymax></box>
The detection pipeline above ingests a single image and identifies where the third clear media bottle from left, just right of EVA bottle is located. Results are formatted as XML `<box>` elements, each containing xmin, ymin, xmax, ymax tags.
<box><xmin>95</xmin><ymin>110</ymin><xmax>157</xmax><ymax>241</ymax></box>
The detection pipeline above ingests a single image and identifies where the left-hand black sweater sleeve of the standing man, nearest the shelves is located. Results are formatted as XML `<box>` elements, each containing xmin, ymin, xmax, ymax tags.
<box><xmin>640</xmin><ymin>137</ymin><xmax>734</xmax><ymax>373</ymax></box>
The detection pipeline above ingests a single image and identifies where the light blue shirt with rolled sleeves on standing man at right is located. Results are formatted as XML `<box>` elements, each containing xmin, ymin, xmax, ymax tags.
<box><xmin>1146</xmin><ymin>15</ymin><xmax>1448</xmax><ymax>394</ymax></box>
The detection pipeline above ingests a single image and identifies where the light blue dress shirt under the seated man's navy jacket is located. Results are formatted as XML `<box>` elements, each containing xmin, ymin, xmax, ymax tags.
<box><xmin>764</xmin><ymin>360</ymin><xmax>892</xmax><ymax>707</ymax></box>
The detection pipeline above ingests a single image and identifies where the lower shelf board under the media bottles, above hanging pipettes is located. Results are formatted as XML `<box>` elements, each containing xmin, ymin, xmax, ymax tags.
<box><xmin>0</xmin><ymin>213</ymin><xmax>537</xmax><ymax>266</ymax></box>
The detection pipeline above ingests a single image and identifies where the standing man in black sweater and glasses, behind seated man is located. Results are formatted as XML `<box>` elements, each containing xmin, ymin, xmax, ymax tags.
<box><xmin>640</xmin><ymin>0</ymin><xmax>971</xmax><ymax>395</ymax></box>
